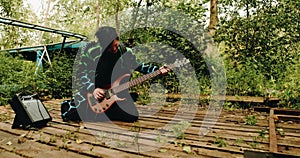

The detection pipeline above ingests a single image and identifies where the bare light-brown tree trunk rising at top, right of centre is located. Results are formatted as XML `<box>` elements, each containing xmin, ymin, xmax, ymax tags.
<box><xmin>208</xmin><ymin>0</ymin><xmax>218</xmax><ymax>36</ymax></box>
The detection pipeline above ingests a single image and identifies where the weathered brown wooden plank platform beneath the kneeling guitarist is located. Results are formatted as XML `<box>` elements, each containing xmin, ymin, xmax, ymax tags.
<box><xmin>0</xmin><ymin>100</ymin><xmax>300</xmax><ymax>158</ymax></box>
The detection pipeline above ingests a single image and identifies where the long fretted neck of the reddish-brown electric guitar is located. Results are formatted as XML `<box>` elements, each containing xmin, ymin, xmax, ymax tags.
<box><xmin>112</xmin><ymin>70</ymin><xmax>161</xmax><ymax>94</ymax></box>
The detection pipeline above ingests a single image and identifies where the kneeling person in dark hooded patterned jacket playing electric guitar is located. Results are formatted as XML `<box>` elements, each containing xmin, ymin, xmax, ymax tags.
<box><xmin>77</xmin><ymin>26</ymin><xmax>170</xmax><ymax>122</ymax></box>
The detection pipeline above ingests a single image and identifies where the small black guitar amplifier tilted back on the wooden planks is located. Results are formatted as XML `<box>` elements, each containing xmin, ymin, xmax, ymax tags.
<box><xmin>9</xmin><ymin>94</ymin><xmax>52</xmax><ymax>129</ymax></box>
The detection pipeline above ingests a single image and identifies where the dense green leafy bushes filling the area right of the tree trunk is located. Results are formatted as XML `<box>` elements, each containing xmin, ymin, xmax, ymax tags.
<box><xmin>214</xmin><ymin>0</ymin><xmax>300</xmax><ymax>106</ymax></box>
